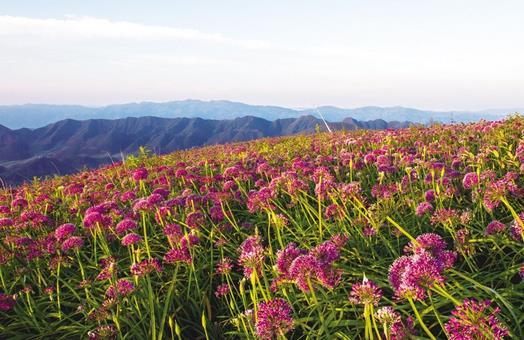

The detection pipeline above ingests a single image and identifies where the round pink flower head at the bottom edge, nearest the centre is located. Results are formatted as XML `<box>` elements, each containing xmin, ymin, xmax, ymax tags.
<box><xmin>255</xmin><ymin>298</ymin><xmax>293</xmax><ymax>340</ymax></box>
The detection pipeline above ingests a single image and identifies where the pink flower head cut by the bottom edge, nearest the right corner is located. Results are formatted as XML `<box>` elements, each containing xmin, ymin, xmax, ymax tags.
<box><xmin>444</xmin><ymin>299</ymin><xmax>509</xmax><ymax>340</ymax></box>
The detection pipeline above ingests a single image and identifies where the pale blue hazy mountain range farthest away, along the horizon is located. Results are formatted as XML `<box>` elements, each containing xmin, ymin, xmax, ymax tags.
<box><xmin>0</xmin><ymin>99</ymin><xmax>524</xmax><ymax>129</ymax></box>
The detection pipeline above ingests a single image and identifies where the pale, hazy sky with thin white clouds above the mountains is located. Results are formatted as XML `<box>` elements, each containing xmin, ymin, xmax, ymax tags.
<box><xmin>0</xmin><ymin>0</ymin><xmax>524</xmax><ymax>110</ymax></box>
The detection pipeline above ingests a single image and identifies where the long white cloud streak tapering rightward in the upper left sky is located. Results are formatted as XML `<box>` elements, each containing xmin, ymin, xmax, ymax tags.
<box><xmin>0</xmin><ymin>15</ymin><xmax>270</xmax><ymax>49</ymax></box>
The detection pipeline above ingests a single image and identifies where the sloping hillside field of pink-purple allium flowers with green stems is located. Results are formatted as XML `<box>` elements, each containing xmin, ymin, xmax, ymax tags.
<box><xmin>0</xmin><ymin>116</ymin><xmax>524</xmax><ymax>340</ymax></box>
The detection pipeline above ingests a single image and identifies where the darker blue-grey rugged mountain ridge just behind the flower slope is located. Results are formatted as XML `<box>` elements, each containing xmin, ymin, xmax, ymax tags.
<box><xmin>0</xmin><ymin>115</ymin><xmax>411</xmax><ymax>184</ymax></box>
